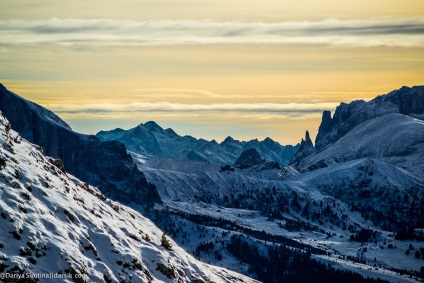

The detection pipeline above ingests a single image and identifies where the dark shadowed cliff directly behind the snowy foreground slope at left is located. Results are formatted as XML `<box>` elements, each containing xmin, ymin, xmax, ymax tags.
<box><xmin>0</xmin><ymin>84</ymin><xmax>161</xmax><ymax>206</ymax></box>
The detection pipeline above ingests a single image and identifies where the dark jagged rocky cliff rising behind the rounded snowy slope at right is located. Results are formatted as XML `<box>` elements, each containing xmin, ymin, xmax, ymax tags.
<box><xmin>315</xmin><ymin>86</ymin><xmax>424</xmax><ymax>151</ymax></box>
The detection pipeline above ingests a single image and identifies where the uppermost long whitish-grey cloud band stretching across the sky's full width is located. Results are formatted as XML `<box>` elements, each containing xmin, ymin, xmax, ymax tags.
<box><xmin>0</xmin><ymin>17</ymin><xmax>424</xmax><ymax>47</ymax></box>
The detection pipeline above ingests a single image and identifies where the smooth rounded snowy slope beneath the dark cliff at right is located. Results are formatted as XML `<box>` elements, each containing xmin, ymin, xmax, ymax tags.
<box><xmin>298</xmin><ymin>114</ymin><xmax>424</xmax><ymax>175</ymax></box>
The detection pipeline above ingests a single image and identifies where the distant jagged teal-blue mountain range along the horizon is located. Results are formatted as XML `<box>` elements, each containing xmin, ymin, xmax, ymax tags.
<box><xmin>96</xmin><ymin>121</ymin><xmax>298</xmax><ymax>165</ymax></box>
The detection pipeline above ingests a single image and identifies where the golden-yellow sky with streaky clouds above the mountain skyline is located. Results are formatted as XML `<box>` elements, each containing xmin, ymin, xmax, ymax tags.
<box><xmin>0</xmin><ymin>0</ymin><xmax>424</xmax><ymax>144</ymax></box>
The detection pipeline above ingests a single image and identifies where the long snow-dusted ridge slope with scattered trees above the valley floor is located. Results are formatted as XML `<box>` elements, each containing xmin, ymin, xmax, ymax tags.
<box><xmin>139</xmin><ymin>149</ymin><xmax>424</xmax><ymax>232</ymax></box>
